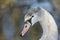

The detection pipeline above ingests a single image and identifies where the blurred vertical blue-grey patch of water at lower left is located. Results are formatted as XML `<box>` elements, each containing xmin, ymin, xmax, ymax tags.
<box><xmin>3</xmin><ymin>14</ymin><xmax>15</xmax><ymax>40</ymax></box>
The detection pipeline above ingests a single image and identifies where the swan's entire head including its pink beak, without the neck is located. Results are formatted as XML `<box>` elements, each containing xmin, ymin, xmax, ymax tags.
<box><xmin>20</xmin><ymin>8</ymin><xmax>39</xmax><ymax>36</ymax></box>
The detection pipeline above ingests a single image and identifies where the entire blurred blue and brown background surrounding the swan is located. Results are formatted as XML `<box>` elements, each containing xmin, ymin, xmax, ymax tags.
<box><xmin>0</xmin><ymin>0</ymin><xmax>60</xmax><ymax>40</ymax></box>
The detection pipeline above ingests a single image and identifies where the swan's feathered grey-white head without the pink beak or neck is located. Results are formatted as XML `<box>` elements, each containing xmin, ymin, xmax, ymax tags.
<box><xmin>24</xmin><ymin>7</ymin><xmax>41</xmax><ymax>26</ymax></box>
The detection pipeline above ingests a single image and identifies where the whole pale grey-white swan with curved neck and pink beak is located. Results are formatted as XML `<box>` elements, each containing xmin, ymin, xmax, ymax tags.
<box><xmin>20</xmin><ymin>7</ymin><xmax>58</xmax><ymax>40</ymax></box>
